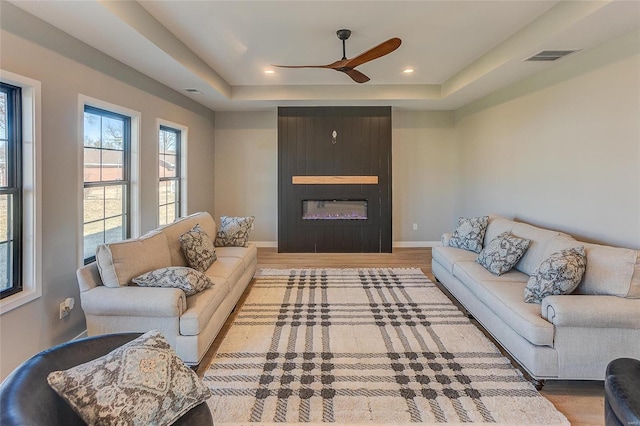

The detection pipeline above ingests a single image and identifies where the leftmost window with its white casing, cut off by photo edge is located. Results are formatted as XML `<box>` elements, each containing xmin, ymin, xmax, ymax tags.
<box><xmin>0</xmin><ymin>70</ymin><xmax>42</xmax><ymax>314</ymax></box>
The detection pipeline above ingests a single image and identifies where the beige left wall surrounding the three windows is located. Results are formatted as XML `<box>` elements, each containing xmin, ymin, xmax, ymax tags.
<box><xmin>0</xmin><ymin>2</ymin><xmax>214</xmax><ymax>379</ymax></box>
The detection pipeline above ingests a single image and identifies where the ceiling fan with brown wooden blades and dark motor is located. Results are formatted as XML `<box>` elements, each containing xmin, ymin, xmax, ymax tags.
<box><xmin>273</xmin><ymin>29</ymin><xmax>402</xmax><ymax>83</ymax></box>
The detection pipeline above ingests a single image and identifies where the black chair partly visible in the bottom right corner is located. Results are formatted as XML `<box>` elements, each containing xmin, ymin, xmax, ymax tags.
<box><xmin>604</xmin><ymin>358</ymin><xmax>640</xmax><ymax>426</ymax></box>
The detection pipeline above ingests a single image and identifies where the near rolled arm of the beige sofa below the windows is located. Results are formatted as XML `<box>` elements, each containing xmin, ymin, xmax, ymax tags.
<box><xmin>80</xmin><ymin>286</ymin><xmax>187</xmax><ymax>317</ymax></box>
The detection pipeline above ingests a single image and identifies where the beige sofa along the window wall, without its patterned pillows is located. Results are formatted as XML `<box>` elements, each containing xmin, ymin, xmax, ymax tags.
<box><xmin>77</xmin><ymin>213</ymin><xmax>257</xmax><ymax>365</ymax></box>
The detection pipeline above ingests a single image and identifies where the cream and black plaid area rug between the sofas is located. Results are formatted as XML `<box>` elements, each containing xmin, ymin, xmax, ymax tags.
<box><xmin>204</xmin><ymin>269</ymin><xmax>569</xmax><ymax>425</ymax></box>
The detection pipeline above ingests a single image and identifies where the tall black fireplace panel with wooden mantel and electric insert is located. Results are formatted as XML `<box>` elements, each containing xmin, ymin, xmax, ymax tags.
<box><xmin>278</xmin><ymin>107</ymin><xmax>392</xmax><ymax>253</ymax></box>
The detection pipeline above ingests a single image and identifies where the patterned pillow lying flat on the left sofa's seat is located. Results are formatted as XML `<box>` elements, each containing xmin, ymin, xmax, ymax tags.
<box><xmin>133</xmin><ymin>266</ymin><xmax>213</xmax><ymax>296</ymax></box>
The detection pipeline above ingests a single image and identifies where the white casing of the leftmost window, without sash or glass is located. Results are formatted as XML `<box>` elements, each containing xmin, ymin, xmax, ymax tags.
<box><xmin>0</xmin><ymin>69</ymin><xmax>42</xmax><ymax>315</ymax></box>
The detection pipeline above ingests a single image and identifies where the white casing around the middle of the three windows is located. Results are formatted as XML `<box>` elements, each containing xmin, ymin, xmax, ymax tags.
<box><xmin>76</xmin><ymin>94</ymin><xmax>142</xmax><ymax>267</ymax></box>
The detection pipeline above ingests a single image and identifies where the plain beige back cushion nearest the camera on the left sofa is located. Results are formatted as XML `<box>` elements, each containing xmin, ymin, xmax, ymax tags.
<box><xmin>96</xmin><ymin>231</ymin><xmax>171</xmax><ymax>287</ymax></box>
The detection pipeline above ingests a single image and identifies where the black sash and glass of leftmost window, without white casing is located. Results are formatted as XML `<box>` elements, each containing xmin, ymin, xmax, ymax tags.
<box><xmin>0</xmin><ymin>83</ymin><xmax>22</xmax><ymax>299</ymax></box>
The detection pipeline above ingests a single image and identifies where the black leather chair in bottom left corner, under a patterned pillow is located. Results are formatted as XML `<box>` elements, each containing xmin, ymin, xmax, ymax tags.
<box><xmin>0</xmin><ymin>333</ymin><xmax>213</xmax><ymax>426</ymax></box>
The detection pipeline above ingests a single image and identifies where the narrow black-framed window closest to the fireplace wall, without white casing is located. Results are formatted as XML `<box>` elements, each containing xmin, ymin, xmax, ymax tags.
<box><xmin>158</xmin><ymin>126</ymin><xmax>182</xmax><ymax>225</ymax></box>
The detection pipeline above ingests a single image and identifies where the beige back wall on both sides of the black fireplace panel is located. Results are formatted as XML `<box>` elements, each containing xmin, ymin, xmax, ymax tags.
<box><xmin>215</xmin><ymin>110</ymin><xmax>458</xmax><ymax>245</ymax></box>
